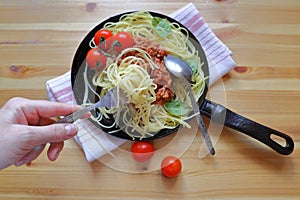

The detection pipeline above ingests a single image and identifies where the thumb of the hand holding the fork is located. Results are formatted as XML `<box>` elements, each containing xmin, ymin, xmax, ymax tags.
<box><xmin>29</xmin><ymin>124</ymin><xmax>78</xmax><ymax>145</ymax></box>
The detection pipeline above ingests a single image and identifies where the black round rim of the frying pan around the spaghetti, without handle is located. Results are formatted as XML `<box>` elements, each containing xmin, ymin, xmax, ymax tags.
<box><xmin>71</xmin><ymin>11</ymin><xmax>209</xmax><ymax>141</ymax></box>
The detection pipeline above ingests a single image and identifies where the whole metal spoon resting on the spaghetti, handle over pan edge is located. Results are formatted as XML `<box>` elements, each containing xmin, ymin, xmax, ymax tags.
<box><xmin>164</xmin><ymin>55</ymin><xmax>215</xmax><ymax>155</ymax></box>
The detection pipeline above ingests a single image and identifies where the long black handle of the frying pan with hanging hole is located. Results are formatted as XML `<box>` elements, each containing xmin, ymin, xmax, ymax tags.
<box><xmin>200</xmin><ymin>99</ymin><xmax>294</xmax><ymax>155</ymax></box>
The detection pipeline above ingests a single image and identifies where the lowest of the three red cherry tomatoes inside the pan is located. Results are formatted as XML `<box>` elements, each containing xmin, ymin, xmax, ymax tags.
<box><xmin>86</xmin><ymin>48</ymin><xmax>107</xmax><ymax>70</ymax></box>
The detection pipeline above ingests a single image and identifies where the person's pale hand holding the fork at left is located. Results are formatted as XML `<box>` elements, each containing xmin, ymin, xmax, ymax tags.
<box><xmin>0</xmin><ymin>97</ymin><xmax>81</xmax><ymax>169</ymax></box>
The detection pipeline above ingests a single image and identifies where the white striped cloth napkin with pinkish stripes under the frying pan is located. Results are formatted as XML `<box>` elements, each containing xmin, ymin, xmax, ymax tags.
<box><xmin>46</xmin><ymin>3</ymin><xmax>236</xmax><ymax>162</ymax></box>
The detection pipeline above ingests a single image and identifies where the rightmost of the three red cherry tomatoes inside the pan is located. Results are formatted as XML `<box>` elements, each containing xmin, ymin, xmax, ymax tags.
<box><xmin>112</xmin><ymin>32</ymin><xmax>134</xmax><ymax>53</ymax></box>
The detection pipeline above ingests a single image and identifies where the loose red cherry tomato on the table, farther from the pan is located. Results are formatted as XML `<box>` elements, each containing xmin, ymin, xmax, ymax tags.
<box><xmin>161</xmin><ymin>156</ymin><xmax>182</xmax><ymax>178</ymax></box>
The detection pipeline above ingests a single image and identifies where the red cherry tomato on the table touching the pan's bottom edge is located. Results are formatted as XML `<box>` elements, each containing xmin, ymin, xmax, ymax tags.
<box><xmin>131</xmin><ymin>141</ymin><xmax>154</xmax><ymax>162</ymax></box>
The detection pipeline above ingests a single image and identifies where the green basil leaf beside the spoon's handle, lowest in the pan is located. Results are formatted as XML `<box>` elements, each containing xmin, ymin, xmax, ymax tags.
<box><xmin>164</xmin><ymin>100</ymin><xmax>191</xmax><ymax>116</ymax></box>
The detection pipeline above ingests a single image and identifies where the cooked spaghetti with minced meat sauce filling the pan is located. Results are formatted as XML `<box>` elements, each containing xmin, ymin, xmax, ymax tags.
<box><xmin>84</xmin><ymin>12</ymin><xmax>205</xmax><ymax>139</ymax></box>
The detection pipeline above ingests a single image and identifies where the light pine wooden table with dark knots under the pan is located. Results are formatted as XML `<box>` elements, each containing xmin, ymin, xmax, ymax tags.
<box><xmin>0</xmin><ymin>0</ymin><xmax>300</xmax><ymax>200</ymax></box>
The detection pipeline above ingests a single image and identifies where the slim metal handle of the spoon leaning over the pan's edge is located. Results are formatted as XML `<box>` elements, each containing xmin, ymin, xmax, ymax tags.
<box><xmin>184</xmin><ymin>79</ymin><xmax>216</xmax><ymax>155</ymax></box>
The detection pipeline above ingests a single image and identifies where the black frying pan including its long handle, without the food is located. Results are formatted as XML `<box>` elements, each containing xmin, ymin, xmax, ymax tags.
<box><xmin>71</xmin><ymin>12</ymin><xmax>294</xmax><ymax>155</ymax></box>
